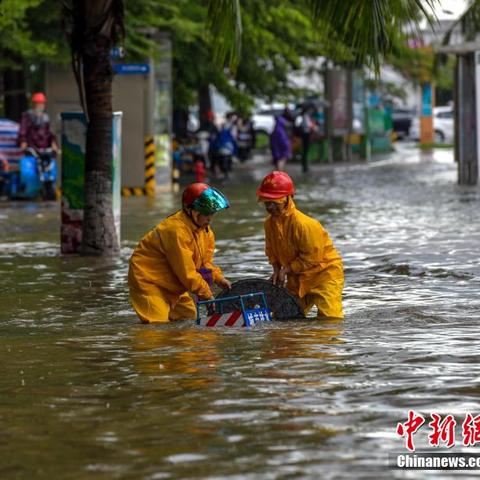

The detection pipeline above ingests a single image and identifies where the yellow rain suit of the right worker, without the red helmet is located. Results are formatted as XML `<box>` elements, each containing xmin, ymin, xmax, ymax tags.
<box><xmin>265</xmin><ymin>197</ymin><xmax>344</xmax><ymax>318</ymax></box>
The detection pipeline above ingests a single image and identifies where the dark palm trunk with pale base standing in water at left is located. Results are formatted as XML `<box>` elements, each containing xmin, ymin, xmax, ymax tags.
<box><xmin>64</xmin><ymin>0</ymin><xmax>124</xmax><ymax>255</ymax></box>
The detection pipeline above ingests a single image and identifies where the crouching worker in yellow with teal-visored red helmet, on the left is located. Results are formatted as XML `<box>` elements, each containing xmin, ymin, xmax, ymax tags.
<box><xmin>128</xmin><ymin>183</ymin><xmax>231</xmax><ymax>323</ymax></box>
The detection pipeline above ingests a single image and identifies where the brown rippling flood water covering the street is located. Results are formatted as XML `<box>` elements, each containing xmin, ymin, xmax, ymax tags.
<box><xmin>0</xmin><ymin>146</ymin><xmax>480</xmax><ymax>480</ymax></box>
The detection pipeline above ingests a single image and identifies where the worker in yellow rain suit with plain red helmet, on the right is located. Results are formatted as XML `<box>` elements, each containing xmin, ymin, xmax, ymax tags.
<box><xmin>257</xmin><ymin>171</ymin><xmax>344</xmax><ymax>318</ymax></box>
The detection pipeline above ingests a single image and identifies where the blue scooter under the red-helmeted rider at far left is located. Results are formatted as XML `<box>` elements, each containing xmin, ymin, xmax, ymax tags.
<box><xmin>9</xmin><ymin>147</ymin><xmax>57</xmax><ymax>200</ymax></box>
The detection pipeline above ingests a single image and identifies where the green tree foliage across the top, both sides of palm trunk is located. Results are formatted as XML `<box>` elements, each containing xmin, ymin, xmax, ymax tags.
<box><xmin>0</xmin><ymin>0</ymin><xmax>436</xmax><ymax>110</ymax></box>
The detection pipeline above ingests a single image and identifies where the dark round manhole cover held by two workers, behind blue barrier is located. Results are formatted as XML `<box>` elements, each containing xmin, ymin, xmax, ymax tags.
<box><xmin>217</xmin><ymin>278</ymin><xmax>305</xmax><ymax>320</ymax></box>
